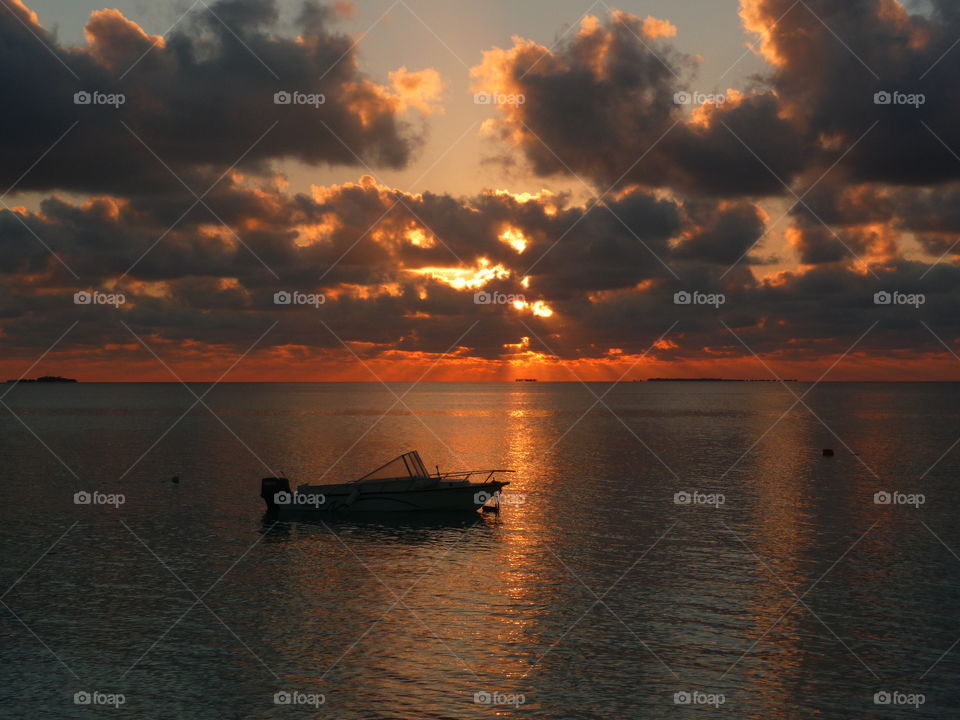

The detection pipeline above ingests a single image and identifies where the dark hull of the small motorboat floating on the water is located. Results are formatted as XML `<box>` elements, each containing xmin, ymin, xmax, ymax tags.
<box><xmin>268</xmin><ymin>482</ymin><xmax>508</xmax><ymax>521</ymax></box>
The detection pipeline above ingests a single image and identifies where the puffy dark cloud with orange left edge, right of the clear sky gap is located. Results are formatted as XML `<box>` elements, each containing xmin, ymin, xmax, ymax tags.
<box><xmin>473</xmin><ymin>11</ymin><xmax>804</xmax><ymax>201</ymax></box>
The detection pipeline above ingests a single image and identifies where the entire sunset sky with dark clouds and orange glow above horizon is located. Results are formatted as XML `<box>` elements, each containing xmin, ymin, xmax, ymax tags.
<box><xmin>0</xmin><ymin>0</ymin><xmax>960</xmax><ymax>381</ymax></box>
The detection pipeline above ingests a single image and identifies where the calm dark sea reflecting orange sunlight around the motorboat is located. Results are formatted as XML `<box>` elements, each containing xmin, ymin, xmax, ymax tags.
<box><xmin>0</xmin><ymin>383</ymin><xmax>960</xmax><ymax>719</ymax></box>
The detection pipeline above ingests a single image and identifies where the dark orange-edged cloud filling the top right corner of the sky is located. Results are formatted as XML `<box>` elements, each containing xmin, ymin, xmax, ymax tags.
<box><xmin>741</xmin><ymin>0</ymin><xmax>960</xmax><ymax>185</ymax></box>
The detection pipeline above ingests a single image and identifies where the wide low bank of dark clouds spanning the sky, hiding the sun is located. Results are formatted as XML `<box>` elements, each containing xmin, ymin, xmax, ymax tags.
<box><xmin>7</xmin><ymin>172</ymin><xmax>960</xmax><ymax>366</ymax></box>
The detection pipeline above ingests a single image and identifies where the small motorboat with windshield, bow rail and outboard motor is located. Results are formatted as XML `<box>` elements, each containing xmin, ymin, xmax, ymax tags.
<box><xmin>260</xmin><ymin>450</ymin><xmax>513</xmax><ymax>521</ymax></box>
